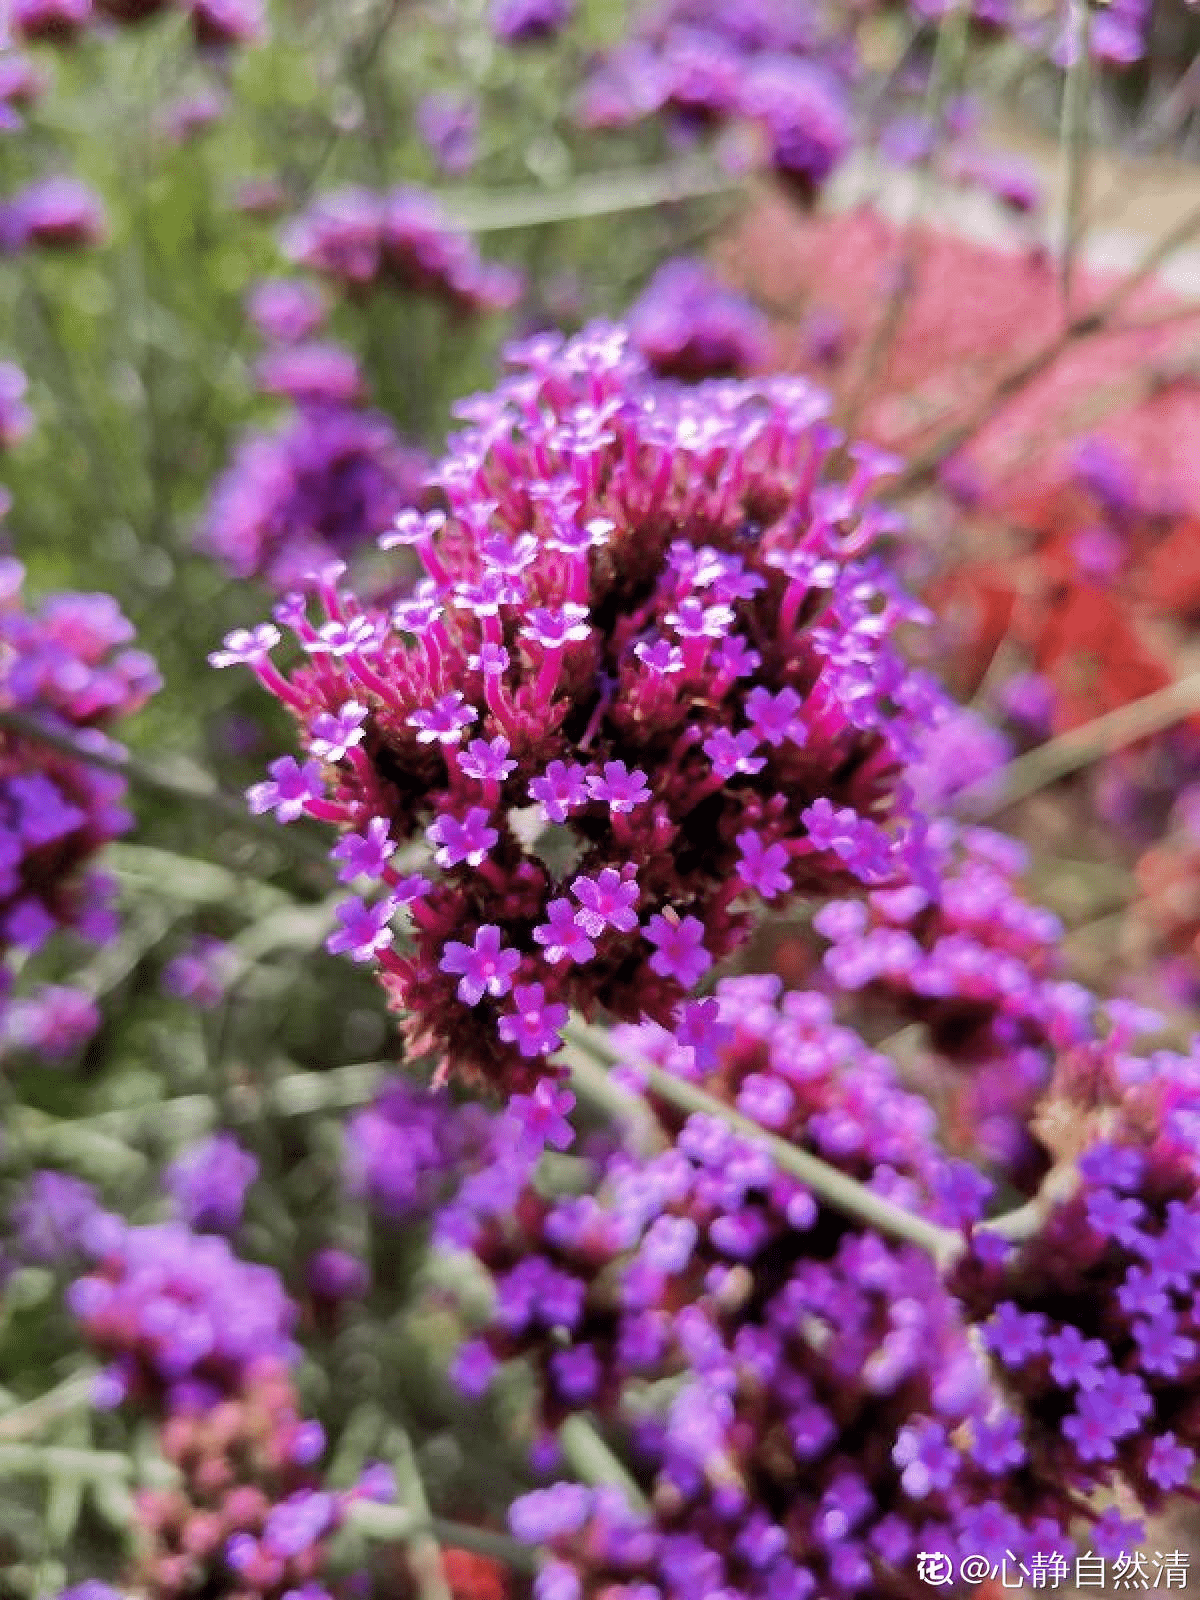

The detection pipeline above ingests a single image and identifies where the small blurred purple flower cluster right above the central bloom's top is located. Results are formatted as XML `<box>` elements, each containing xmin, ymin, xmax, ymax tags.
<box><xmin>629</xmin><ymin>258</ymin><xmax>768</xmax><ymax>388</ymax></box>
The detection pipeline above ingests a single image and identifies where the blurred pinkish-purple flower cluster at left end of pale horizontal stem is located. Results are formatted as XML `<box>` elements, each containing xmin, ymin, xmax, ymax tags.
<box><xmin>283</xmin><ymin>186</ymin><xmax>520</xmax><ymax>314</ymax></box>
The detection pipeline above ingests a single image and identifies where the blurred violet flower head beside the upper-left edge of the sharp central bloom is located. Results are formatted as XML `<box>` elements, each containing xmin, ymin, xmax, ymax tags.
<box><xmin>202</xmin><ymin>405</ymin><xmax>429</xmax><ymax>589</ymax></box>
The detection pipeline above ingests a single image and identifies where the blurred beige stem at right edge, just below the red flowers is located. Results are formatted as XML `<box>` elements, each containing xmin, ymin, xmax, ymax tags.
<box><xmin>954</xmin><ymin>672</ymin><xmax>1200</xmax><ymax>822</ymax></box>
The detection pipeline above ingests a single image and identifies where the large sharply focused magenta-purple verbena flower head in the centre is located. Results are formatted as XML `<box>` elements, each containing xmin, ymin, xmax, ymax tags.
<box><xmin>216</xmin><ymin>328</ymin><xmax>938</xmax><ymax>1090</ymax></box>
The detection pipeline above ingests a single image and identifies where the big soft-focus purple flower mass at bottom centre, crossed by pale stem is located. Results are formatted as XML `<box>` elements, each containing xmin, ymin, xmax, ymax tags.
<box><xmin>456</xmin><ymin>979</ymin><xmax>1067</xmax><ymax>1600</ymax></box>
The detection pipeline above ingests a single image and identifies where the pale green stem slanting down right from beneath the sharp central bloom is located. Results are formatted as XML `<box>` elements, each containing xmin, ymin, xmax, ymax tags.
<box><xmin>566</xmin><ymin>1022</ymin><xmax>963</xmax><ymax>1267</ymax></box>
